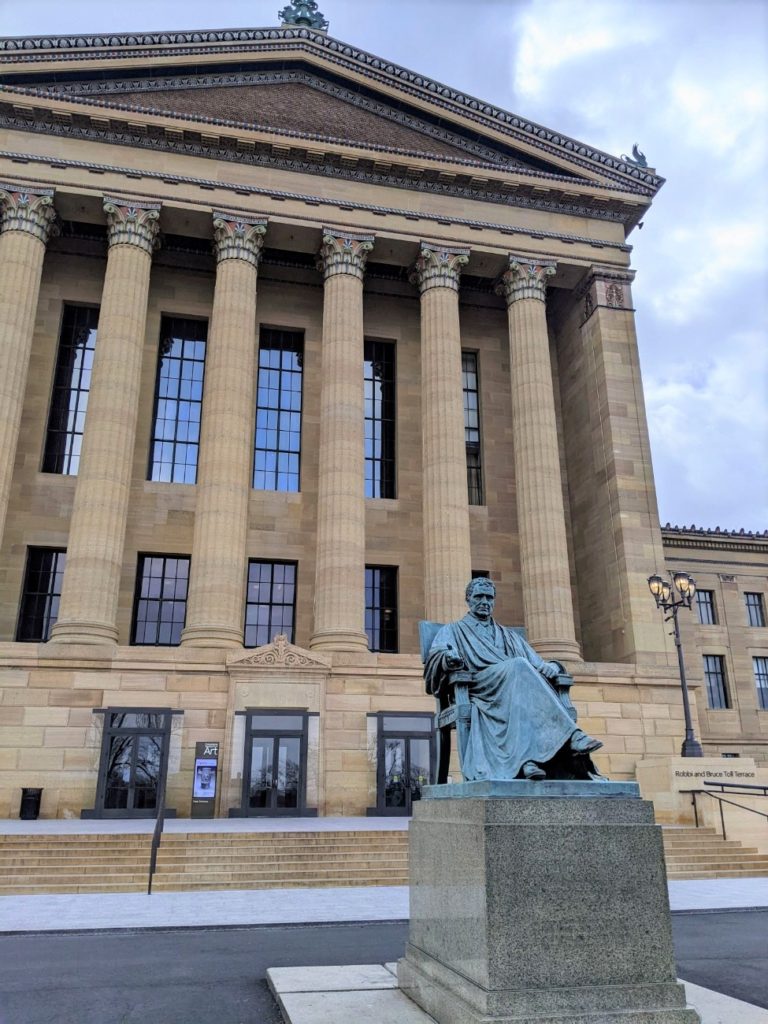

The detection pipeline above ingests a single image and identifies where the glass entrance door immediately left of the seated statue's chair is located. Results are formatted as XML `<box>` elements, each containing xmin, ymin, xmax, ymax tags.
<box><xmin>376</xmin><ymin>713</ymin><xmax>434</xmax><ymax>816</ymax></box>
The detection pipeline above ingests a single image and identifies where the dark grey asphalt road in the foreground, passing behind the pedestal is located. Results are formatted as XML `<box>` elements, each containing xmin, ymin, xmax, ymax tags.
<box><xmin>0</xmin><ymin>910</ymin><xmax>768</xmax><ymax>1024</ymax></box>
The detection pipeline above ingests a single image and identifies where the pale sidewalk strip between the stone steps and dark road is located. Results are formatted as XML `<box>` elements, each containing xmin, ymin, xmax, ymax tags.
<box><xmin>0</xmin><ymin>879</ymin><xmax>768</xmax><ymax>933</ymax></box>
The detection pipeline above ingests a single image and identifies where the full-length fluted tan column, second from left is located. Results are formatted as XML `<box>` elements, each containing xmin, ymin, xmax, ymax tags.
<box><xmin>51</xmin><ymin>199</ymin><xmax>160</xmax><ymax>643</ymax></box>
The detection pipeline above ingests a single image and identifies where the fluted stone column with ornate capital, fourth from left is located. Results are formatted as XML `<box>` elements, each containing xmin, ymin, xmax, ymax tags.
<box><xmin>310</xmin><ymin>228</ymin><xmax>374</xmax><ymax>650</ymax></box>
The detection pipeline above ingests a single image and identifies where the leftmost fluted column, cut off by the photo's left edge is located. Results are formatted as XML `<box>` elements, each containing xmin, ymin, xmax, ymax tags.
<box><xmin>0</xmin><ymin>184</ymin><xmax>56</xmax><ymax>541</ymax></box>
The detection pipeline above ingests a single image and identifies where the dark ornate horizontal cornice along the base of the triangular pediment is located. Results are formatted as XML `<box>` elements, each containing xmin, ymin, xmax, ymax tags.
<box><xmin>0</xmin><ymin>103</ymin><xmax>644</xmax><ymax>225</ymax></box>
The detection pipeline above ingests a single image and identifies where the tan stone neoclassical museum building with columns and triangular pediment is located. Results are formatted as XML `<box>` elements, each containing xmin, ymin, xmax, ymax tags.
<box><xmin>0</xmin><ymin>2</ymin><xmax>768</xmax><ymax>817</ymax></box>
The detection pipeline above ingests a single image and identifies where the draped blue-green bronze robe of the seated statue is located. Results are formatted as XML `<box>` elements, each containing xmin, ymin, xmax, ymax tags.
<box><xmin>424</xmin><ymin>614</ymin><xmax>577</xmax><ymax>781</ymax></box>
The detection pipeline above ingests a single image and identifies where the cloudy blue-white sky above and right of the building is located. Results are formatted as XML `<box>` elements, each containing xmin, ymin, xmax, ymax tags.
<box><xmin>0</xmin><ymin>0</ymin><xmax>768</xmax><ymax>530</ymax></box>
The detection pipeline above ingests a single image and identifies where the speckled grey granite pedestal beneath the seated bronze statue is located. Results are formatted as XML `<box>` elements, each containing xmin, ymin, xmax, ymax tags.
<box><xmin>397</xmin><ymin>780</ymin><xmax>699</xmax><ymax>1024</ymax></box>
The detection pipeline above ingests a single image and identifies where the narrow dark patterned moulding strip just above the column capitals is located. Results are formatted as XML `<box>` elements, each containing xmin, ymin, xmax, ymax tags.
<box><xmin>3</xmin><ymin>153</ymin><xmax>632</xmax><ymax>253</ymax></box>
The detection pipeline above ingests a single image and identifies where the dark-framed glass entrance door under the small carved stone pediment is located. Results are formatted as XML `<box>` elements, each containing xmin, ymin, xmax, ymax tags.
<box><xmin>241</xmin><ymin>711</ymin><xmax>307</xmax><ymax>817</ymax></box>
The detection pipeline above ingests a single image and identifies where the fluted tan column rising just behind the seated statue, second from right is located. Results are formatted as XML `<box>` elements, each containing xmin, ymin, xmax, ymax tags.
<box><xmin>412</xmin><ymin>242</ymin><xmax>471</xmax><ymax>623</ymax></box>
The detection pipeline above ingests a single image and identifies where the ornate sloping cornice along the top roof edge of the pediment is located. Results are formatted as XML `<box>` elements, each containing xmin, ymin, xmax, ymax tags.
<box><xmin>0</xmin><ymin>28</ymin><xmax>664</xmax><ymax>195</ymax></box>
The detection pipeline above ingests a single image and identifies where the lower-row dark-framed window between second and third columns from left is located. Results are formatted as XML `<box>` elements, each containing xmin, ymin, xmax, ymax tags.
<box><xmin>131</xmin><ymin>555</ymin><xmax>189</xmax><ymax>647</ymax></box>
